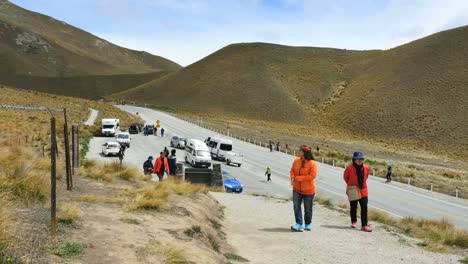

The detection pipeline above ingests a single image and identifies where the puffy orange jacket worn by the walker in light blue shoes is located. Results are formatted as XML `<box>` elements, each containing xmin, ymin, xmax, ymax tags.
<box><xmin>290</xmin><ymin>158</ymin><xmax>317</xmax><ymax>195</ymax></box>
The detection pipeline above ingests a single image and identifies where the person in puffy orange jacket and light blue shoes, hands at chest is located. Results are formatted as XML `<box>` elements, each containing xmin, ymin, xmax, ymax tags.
<box><xmin>290</xmin><ymin>145</ymin><xmax>317</xmax><ymax>232</ymax></box>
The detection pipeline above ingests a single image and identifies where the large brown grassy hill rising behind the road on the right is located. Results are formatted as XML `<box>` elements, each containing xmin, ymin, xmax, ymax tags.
<box><xmin>110</xmin><ymin>27</ymin><xmax>468</xmax><ymax>153</ymax></box>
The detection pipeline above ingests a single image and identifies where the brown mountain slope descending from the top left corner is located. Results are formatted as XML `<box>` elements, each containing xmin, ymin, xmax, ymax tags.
<box><xmin>0</xmin><ymin>0</ymin><xmax>181</xmax><ymax>76</ymax></box>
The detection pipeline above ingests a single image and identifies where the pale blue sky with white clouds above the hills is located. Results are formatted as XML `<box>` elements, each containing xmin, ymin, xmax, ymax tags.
<box><xmin>10</xmin><ymin>0</ymin><xmax>468</xmax><ymax>66</ymax></box>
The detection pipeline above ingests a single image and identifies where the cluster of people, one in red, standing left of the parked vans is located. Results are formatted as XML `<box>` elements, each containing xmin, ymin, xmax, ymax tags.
<box><xmin>143</xmin><ymin>147</ymin><xmax>177</xmax><ymax>181</ymax></box>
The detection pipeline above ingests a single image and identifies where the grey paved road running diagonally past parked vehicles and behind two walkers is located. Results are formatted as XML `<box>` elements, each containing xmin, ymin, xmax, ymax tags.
<box><xmin>90</xmin><ymin>106</ymin><xmax>468</xmax><ymax>229</ymax></box>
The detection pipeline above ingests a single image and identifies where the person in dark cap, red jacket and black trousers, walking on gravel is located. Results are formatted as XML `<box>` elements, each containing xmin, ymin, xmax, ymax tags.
<box><xmin>343</xmin><ymin>151</ymin><xmax>372</xmax><ymax>232</ymax></box>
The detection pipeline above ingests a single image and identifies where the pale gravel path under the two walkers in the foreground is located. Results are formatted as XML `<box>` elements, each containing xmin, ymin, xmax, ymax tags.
<box><xmin>212</xmin><ymin>193</ymin><xmax>462</xmax><ymax>264</ymax></box>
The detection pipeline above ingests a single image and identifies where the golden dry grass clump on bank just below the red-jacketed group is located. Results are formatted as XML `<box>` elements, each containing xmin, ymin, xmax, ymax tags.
<box><xmin>127</xmin><ymin>177</ymin><xmax>208</xmax><ymax>210</ymax></box>
